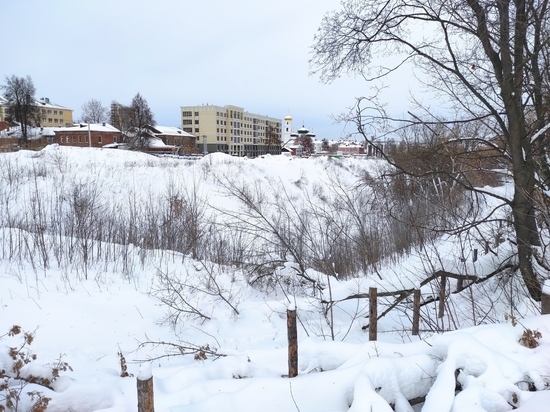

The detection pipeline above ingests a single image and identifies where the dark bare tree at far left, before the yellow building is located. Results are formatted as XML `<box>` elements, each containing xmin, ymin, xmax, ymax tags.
<box><xmin>5</xmin><ymin>75</ymin><xmax>38</xmax><ymax>144</ymax></box>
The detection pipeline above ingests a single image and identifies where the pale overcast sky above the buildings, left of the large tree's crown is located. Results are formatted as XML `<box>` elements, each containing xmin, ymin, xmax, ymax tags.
<box><xmin>0</xmin><ymin>0</ymin><xmax>414</xmax><ymax>139</ymax></box>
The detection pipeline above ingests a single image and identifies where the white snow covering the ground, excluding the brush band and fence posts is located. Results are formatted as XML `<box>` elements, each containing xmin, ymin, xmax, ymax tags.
<box><xmin>0</xmin><ymin>145</ymin><xmax>550</xmax><ymax>412</ymax></box>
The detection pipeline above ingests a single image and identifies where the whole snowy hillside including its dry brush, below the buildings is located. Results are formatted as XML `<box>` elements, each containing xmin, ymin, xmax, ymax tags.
<box><xmin>0</xmin><ymin>145</ymin><xmax>550</xmax><ymax>412</ymax></box>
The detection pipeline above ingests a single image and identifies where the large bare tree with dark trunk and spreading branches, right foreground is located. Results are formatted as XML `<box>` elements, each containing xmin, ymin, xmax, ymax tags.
<box><xmin>310</xmin><ymin>0</ymin><xmax>550</xmax><ymax>300</ymax></box>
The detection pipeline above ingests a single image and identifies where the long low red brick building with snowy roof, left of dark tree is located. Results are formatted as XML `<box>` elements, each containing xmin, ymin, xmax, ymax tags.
<box><xmin>54</xmin><ymin>123</ymin><xmax>122</xmax><ymax>147</ymax></box>
